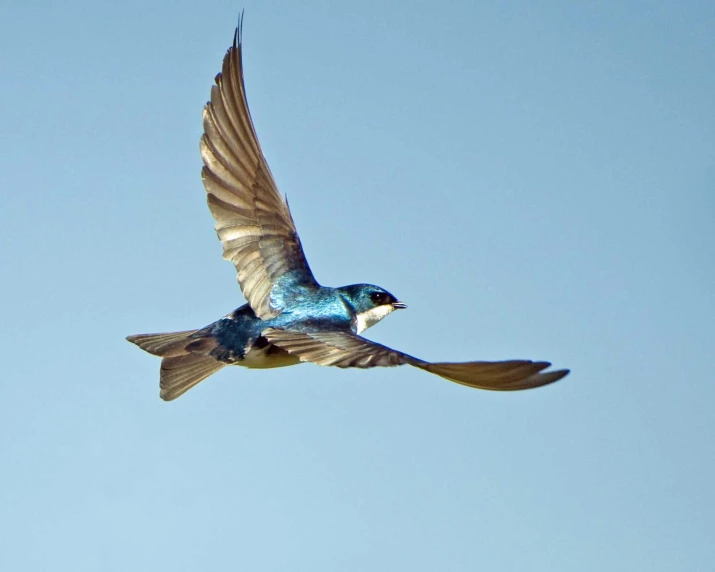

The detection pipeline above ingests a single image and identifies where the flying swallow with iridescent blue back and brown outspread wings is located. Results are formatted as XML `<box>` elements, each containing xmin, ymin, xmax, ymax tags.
<box><xmin>127</xmin><ymin>19</ymin><xmax>569</xmax><ymax>401</ymax></box>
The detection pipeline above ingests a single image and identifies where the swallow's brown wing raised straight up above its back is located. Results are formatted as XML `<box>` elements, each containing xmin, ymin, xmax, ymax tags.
<box><xmin>201</xmin><ymin>23</ymin><xmax>317</xmax><ymax>319</ymax></box>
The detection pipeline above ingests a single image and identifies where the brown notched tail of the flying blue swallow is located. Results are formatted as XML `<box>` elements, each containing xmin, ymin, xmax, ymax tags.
<box><xmin>127</xmin><ymin>330</ymin><xmax>226</xmax><ymax>401</ymax></box>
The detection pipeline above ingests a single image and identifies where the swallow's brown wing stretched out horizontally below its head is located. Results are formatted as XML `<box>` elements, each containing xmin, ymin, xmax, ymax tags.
<box><xmin>263</xmin><ymin>328</ymin><xmax>569</xmax><ymax>391</ymax></box>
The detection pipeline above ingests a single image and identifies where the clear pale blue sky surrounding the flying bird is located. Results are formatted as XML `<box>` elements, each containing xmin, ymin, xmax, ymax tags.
<box><xmin>0</xmin><ymin>0</ymin><xmax>715</xmax><ymax>572</ymax></box>
